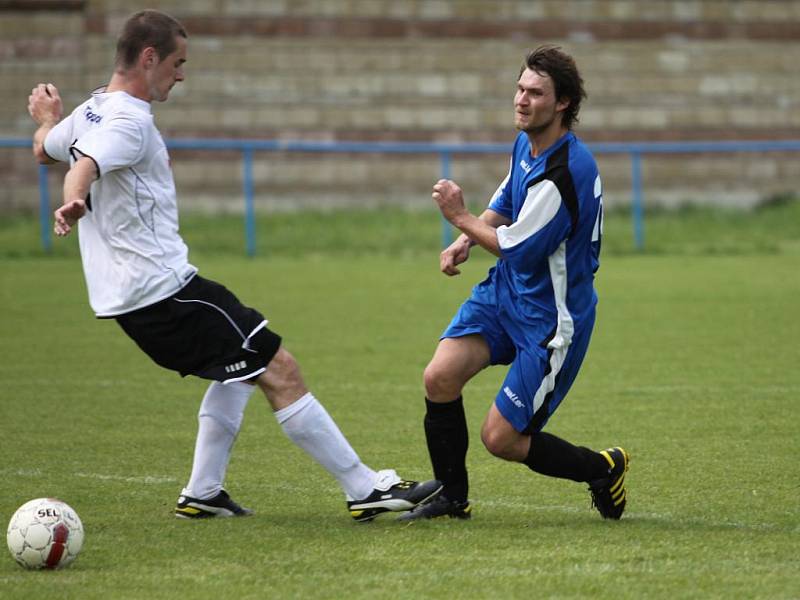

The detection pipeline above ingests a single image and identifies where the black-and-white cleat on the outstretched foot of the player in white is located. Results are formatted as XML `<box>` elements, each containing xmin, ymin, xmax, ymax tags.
<box><xmin>347</xmin><ymin>469</ymin><xmax>442</xmax><ymax>522</ymax></box>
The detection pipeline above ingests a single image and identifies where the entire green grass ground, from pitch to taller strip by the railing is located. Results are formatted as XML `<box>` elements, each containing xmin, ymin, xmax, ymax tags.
<box><xmin>0</xmin><ymin>203</ymin><xmax>800</xmax><ymax>600</ymax></box>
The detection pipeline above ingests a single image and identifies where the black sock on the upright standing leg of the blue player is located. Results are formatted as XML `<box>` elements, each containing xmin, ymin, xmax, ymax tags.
<box><xmin>425</xmin><ymin>396</ymin><xmax>469</xmax><ymax>502</ymax></box>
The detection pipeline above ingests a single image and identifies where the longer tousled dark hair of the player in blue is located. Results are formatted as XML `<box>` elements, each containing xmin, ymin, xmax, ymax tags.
<box><xmin>519</xmin><ymin>45</ymin><xmax>586</xmax><ymax>129</ymax></box>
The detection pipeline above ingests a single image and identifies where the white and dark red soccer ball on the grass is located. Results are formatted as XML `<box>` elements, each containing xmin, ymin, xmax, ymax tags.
<box><xmin>6</xmin><ymin>498</ymin><xmax>83</xmax><ymax>569</ymax></box>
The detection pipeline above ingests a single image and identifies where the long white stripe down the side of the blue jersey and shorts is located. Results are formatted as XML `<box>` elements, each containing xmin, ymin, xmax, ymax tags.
<box><xmin>533</xmin><ymin>241</ymin><xmax>575</xmax><ymax>413</ymax></box>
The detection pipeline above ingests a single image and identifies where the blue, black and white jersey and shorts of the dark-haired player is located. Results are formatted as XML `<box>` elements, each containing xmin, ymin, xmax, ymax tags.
<box><xmin>442</xmin><ymin>133</ymin><xmax>603</xmax><ymax>434</ymax></box>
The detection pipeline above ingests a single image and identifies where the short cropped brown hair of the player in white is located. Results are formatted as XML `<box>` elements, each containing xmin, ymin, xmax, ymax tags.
<box><xmin>116</xmin><ymin>9</ymin><xmax>189</xmax><ymax>69</ymax></box>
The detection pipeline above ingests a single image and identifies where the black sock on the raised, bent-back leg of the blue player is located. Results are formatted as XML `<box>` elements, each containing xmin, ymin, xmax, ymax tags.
<box><xmin>523</xmin><ymin>431</ymin><xmax>608</xmax><ymax>481</ymax></box>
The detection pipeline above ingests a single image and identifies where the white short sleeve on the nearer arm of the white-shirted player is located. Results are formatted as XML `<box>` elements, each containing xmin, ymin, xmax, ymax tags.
<box><xmin>72</xmin><ymin>116</ymin><xmax>146</xmax><ymax>177</ymax></box>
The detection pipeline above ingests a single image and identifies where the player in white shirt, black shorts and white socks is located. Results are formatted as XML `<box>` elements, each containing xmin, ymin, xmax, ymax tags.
<box><xmin>28</xmin><ymin>10</ymin><xmax>441</xmax><ymax>521</ymax></box>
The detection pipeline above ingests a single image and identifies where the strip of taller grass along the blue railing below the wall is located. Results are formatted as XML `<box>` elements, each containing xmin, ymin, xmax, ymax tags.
<box><xmin>0</xmin><ymin>198</ymin><xmax>800</xmax><ymax>258</ymax></box>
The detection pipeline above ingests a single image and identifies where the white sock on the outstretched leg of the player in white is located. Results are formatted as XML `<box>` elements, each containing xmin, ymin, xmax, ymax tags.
<box><xmin>275</xmin><ymin>392</ymin><xmax>377</xmax><ymax>500</ymax></box>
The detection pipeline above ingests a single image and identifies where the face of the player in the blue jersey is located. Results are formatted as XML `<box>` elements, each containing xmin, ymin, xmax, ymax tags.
<box><xmin>514</xmin><ymin>69</ymin><xmax>569</xmax><ymax>133</ymax></box>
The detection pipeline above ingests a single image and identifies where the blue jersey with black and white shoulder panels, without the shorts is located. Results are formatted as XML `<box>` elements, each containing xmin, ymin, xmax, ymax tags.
<box><xmin>489</xmin><ymin>132</ymin><xmax>602</xmax><ymax>346</ymax></box>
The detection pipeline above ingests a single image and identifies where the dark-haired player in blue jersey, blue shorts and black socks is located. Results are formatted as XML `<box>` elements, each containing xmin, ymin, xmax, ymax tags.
<box><xmin>400</xmin><ymin>46</ymin><xmax>628</xmax><ymax>520</ymax></box>
